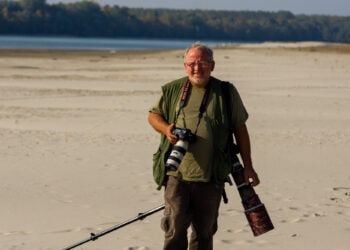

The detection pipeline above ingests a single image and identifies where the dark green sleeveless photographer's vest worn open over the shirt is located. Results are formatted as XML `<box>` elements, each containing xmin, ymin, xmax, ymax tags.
<box><xmin>153</xmin><ymin>77</ymin><xmax>233</xmax><ymax>189</ymax></box>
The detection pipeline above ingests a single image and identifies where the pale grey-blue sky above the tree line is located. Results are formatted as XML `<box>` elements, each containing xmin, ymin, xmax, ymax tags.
<box><xmin>47</xmin><ymin>0</ymin><xmax>350</xmax><ymax>16</ymax></box>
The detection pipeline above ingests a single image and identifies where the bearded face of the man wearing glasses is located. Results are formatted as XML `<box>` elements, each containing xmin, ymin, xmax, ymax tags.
<box><xmin>184</xmin><ymin>49</ymin><xmax>215</xmax><ymax>88</ymax></box>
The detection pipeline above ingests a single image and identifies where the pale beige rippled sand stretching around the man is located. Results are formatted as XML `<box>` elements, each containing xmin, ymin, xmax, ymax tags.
<box><xmin>0</xmin><ymin>43</ymin><xmax>350</xmax><ymax>250</ymax></box>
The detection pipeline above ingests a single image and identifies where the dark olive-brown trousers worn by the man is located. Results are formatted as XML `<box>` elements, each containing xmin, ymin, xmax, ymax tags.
<box><xmin>161</xmin><ymin>176</ymin><xmax>224</xmax><ymax>250</ymax></box>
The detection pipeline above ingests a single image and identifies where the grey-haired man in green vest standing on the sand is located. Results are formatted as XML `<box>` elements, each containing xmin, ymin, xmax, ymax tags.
<box><xmin>148</xmin><ymin>43</ymin><xmax>259</xmax><ymax>250</ymax></box>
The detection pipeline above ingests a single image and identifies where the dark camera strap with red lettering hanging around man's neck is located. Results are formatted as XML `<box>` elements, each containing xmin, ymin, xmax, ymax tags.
<box><xmin>174</xmin><ymin>79</ymin><xmax>211</xmax><ymax>135</ymax></box>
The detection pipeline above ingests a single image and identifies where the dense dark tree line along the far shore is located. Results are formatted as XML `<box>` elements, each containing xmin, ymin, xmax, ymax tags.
<box><xmin>0</xmin><ymin>0</ymin><xmax>350</xmax><ymax>43</ymax></box>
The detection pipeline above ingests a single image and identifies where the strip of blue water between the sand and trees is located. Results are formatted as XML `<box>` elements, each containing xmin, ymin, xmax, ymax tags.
<box><xmin>0</xmin><ymin>36</ymin><xmax>234</xmax><ymax>50</ymax></box>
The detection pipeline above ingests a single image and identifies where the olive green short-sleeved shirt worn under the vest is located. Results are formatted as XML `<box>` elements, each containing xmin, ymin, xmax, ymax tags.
<box><xmin>150</xmin><ymin>79</ymin><xmax>248</xmax><ymax>182</ymax></box>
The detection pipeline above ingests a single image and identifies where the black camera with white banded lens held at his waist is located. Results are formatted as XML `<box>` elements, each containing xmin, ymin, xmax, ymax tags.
<box><xmin>165</xmin><ymin>128</ymin><xmax>196</xmax><ymax>171</ymax></box>
